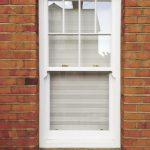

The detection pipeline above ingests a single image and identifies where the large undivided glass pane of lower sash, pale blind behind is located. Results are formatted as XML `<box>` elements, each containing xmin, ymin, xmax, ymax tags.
<box><xmin>50</xmin><ymin>72</ymin><xmax>109</xmax><ymax>130</ymax></box>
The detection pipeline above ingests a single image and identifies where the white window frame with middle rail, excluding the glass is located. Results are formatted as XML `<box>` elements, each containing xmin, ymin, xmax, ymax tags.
<box><xmin>39</xmin><ymin>0</ymin><xmax>121</xmax><ymax>148</ymax></box>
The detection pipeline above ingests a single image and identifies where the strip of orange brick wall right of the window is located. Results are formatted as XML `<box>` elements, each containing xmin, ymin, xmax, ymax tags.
<box><xmin>122</xmin><ymin>0</ymin><xmax>150</xmax><ymax>150</ymax></box>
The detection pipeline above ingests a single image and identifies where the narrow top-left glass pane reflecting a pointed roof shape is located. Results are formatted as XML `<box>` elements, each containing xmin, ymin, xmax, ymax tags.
<box><xmin>48</xmin><ymin>0</ymin><xmax>63</xmax><ymax>33</ymax></box>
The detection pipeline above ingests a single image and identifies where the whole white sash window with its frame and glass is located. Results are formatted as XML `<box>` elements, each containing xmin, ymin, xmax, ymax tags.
<box><xmin>39</xmin><ymin>0</ymin><xmax>121</xmax><ymax>148</ymax></box>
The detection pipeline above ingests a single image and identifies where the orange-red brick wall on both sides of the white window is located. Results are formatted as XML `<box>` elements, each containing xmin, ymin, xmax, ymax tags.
<box><xmin>0</xmin><ymin>0</ymin><xmax>150</xmax><ymax>150</ymax></box>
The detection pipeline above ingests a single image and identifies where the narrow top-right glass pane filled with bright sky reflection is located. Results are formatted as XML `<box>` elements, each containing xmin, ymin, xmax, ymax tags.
<box><xmin>96</xmin><ymin>0</ymin><xmax>112</xmax><ymax>33</ymax></box>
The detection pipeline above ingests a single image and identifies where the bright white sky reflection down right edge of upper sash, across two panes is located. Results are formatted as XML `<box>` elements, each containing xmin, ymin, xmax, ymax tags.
<box><xmin>96</xmin><ymin>0</ymin><xmax>112</xmax><ymax>57</ymax></box>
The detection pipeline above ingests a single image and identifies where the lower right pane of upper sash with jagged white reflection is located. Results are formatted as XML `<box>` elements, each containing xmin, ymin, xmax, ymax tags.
<box><xmin>81</xmin><ymin>35</ymin><xmax>111</xmax><ymax>67</ymax></box>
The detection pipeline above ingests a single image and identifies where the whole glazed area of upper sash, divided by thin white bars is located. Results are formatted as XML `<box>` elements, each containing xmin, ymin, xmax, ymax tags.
<box><xmin>48</xmin><ymin>0</ymin><xmax>112</xmax><ymax>67</ymax></box>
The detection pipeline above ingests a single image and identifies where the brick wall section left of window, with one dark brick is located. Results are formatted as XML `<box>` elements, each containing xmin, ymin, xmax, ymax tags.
<box><xmin>0</xmin><ymin>0</ymin><xmax>38</xmax><ymax>150</ymax></box>
